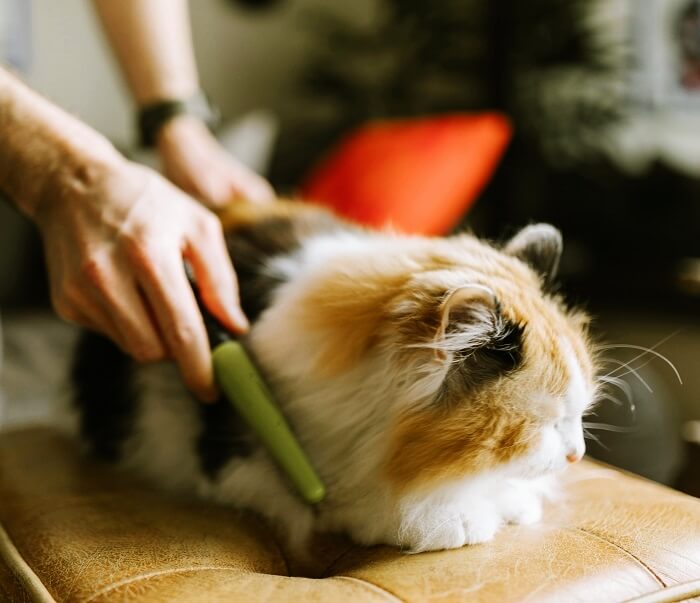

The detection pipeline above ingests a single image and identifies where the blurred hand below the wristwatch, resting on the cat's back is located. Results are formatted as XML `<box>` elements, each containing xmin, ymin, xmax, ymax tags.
<box><xmin>157</xmin><ymin>115</ymin><xmax>275</xmax><ymax>209</ymax></box>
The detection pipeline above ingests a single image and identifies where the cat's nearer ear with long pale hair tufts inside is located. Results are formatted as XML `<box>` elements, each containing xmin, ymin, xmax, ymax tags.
<box><xmin>436</xmin><ymin>283</ymin><xmax>498</xmax><ymax>360</ymax></box>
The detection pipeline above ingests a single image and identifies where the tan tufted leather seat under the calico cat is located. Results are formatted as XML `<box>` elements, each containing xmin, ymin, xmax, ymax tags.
<box><xmin>0</xmin><ymin>429</ymin><xmax>700</xmax><ymax>603</ymax></box>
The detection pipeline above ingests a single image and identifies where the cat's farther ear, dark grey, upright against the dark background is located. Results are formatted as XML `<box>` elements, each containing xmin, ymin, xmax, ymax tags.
<box><xmin>504</xmin><ymin>224</ymin><xmax>563</xmax><ymax>283</ymax></box>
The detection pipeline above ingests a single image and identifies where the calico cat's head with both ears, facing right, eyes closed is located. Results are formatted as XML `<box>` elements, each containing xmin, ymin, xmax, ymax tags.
<box><xmin>386</xmin><ymin>225</ymin><xmax>595</xmax><ymax>488</ymax></box>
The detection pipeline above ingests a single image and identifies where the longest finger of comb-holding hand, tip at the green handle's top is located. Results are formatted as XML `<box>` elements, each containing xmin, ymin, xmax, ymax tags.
<box><xmin>130</xmin><ymin>243</ymin><xmax>217</xmax><ymax>401</ymax></box>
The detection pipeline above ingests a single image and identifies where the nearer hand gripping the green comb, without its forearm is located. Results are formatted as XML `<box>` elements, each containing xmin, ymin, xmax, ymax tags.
<box><xmin>35</xmin><ymin>158</ymin><xmax>247</xmax><ymax>400</ymax></box>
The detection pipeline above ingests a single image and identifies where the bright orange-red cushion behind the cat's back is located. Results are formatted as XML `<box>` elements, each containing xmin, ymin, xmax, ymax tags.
<box><xmin>301</xmin><ymin>113</ymin><xmax>511</xmax><ymax>235</ymax></box>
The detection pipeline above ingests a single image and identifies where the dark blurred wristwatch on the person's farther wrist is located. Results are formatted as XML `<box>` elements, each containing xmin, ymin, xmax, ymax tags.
<box><xmin>138</xmin><ymin>92</ymin><xmax>220</xmax><ymax>147</ymax></box>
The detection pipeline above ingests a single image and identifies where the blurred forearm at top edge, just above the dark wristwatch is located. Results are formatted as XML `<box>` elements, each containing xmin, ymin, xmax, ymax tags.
<box><xmin>94</xmin><ymin>0</ymin><xmax>199</xmax><ymax>105</ymax></box>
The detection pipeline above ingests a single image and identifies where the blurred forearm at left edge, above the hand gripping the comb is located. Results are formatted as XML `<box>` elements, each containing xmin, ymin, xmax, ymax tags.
<box><xmin>0</xmin><ymin>68</ymin><xmax>122</xmax><ymax>218</ymax></box>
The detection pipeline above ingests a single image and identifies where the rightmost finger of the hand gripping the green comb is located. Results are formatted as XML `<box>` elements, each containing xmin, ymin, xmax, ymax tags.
<box><xmin>185</xmin><ymin>216</ymin><xmax>249</xmax><ymax>333</ymax></box>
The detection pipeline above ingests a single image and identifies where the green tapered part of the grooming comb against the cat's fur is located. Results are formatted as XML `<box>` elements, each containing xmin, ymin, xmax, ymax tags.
<box><xmin>212</xmin><ymin>341</ymin><xmax>326</xmax><ymax>504</ymax></box>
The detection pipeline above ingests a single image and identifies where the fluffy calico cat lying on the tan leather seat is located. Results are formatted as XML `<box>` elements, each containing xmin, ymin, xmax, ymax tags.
<box><xmin>73</xmin><ymin>202</ymin><xmax>596</xmax><ymax>552</ymax></box>
